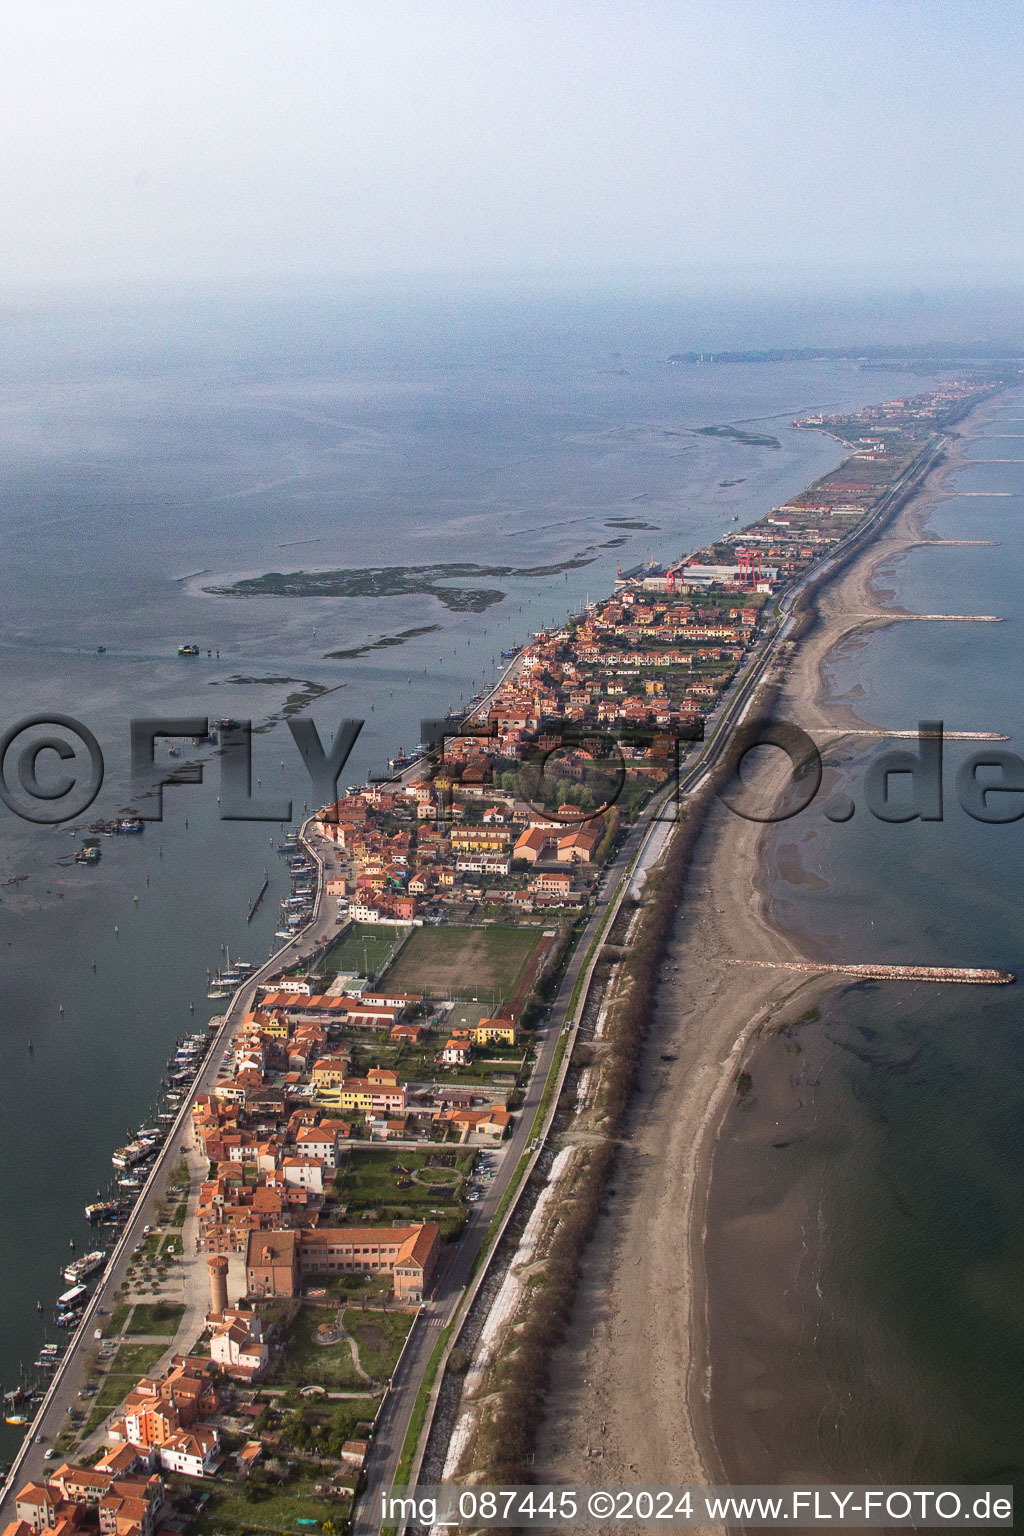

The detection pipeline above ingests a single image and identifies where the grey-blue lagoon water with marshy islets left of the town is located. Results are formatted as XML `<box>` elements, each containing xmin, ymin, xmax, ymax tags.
<box><xmin>0</xmin><ymin>276</ymin><xmax>988</xmax><ymax>1456</ymax></box>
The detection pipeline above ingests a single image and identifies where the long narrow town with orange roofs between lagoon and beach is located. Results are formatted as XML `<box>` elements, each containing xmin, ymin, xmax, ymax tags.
<box><xmin>3</xmin><ymin>379</ymin><xmax>986</xmax><ymax>1536</ymax></box>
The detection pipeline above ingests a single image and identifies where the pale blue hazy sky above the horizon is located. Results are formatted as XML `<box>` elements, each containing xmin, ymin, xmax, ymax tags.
<box><xmin>0</xmin><ymin>0</ymin><xmax>1024</xmax><ymax>283</ymax></box>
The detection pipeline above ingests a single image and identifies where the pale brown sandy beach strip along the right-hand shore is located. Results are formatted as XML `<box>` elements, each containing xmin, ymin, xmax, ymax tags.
<box><xmin>536</xmin><ymin>390</ymin><xmax>992</xmax><ymax>1505</ymax></box>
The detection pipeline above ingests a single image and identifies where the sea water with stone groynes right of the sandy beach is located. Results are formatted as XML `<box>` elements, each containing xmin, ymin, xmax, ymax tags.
<box><xmin>712</xmin><ymin>393</ymin><xmax>1024</xmax><ymax>1482</ymax></box>
